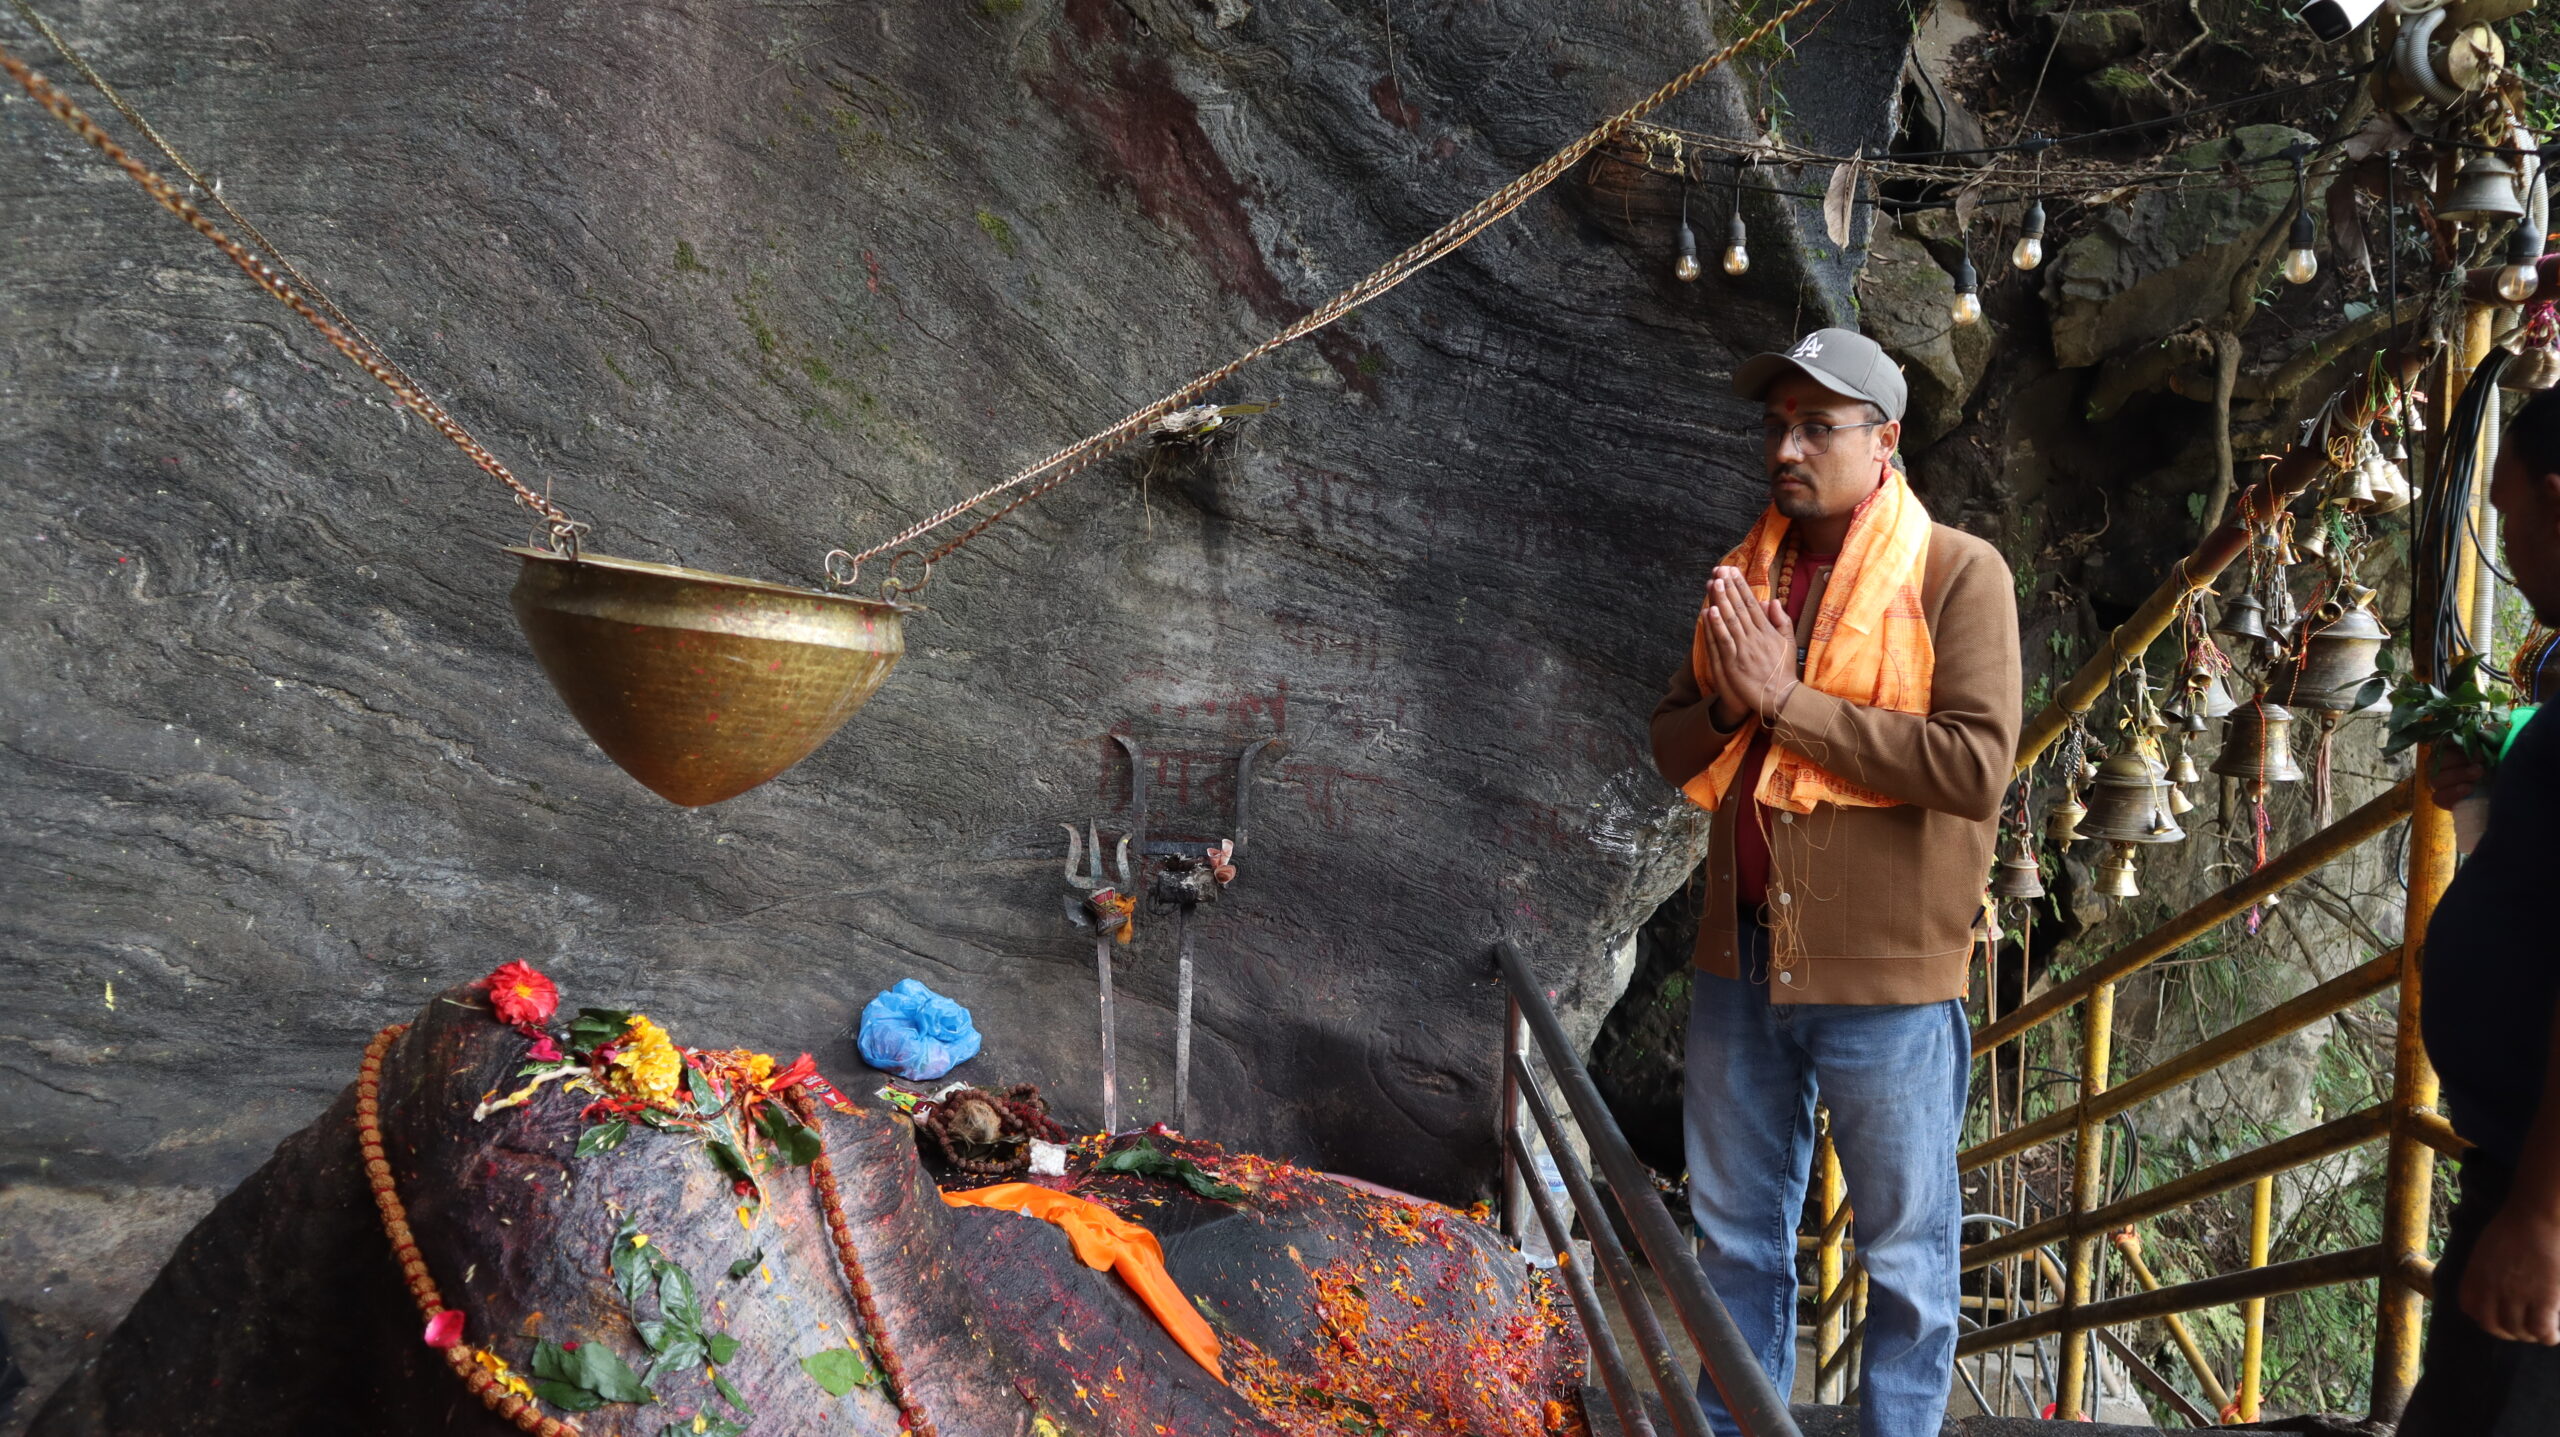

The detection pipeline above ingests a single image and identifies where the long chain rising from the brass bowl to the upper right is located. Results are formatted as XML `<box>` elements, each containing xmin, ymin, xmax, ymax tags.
<box><xmin>827</xmin><ymin>0</ymin><xmax>1812</xmax><ymax>587</ymax></box>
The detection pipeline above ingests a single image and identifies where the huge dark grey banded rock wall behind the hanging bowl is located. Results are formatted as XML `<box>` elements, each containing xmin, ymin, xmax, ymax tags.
<box><xmin>0</xmin><ymin>0</ymin><xmax>1907</xmax><ymax>1413</ymax></box>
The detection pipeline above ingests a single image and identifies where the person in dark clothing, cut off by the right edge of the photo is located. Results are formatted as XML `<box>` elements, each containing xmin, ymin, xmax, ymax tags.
<box><xmin>2399</xmin><ymin>389</ymin><xmax>2560</xmax><ymax>1437</ymax></box>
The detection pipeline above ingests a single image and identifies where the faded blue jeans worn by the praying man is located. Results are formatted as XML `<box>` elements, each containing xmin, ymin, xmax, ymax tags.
<box><xmin>1684</xmin><ymin>922</ymin><xmax>1971</xmax><ymax>1437</ymax></box>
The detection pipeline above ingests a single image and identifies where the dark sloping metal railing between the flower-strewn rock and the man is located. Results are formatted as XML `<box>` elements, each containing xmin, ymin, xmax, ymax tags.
<box><xmin>1492</xmin><ymin>943</ymin><xmax>1802</xmax><ymax>1437</ymax></box>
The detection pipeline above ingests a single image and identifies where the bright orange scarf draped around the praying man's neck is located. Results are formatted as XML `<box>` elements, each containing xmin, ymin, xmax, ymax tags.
<box><xmin>1679</xmin><ymin>469</ymin><xmax>1938</xmax><ymax>815</ymax></box>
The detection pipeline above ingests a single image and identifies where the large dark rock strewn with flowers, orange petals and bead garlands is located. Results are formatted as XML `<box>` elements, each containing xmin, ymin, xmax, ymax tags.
<box><xmin>33</xmin><ymin>981</ymin><xmax>1585</xmax><ymax>1437</ymax></box>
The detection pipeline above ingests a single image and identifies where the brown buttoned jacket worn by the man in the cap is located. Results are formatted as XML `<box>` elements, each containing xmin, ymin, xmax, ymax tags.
<box><xmin>1654</xmin><ymin>525</ymin><xmax>2020</xmax><ymax>1004</ymax></box>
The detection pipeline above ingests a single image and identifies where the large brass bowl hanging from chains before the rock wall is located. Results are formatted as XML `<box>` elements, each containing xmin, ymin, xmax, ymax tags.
<box><xmin>507</xmin><ymin>548</ymin><xmax>906</xmax><ymax>807</ymax></box>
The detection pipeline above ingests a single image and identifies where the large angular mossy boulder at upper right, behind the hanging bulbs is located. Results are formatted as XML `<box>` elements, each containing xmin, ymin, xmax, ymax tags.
<box><xmin>2045</xmin><ymin>126</ymin><xmax>2312</xmax><ymax>369</ymax></box>
